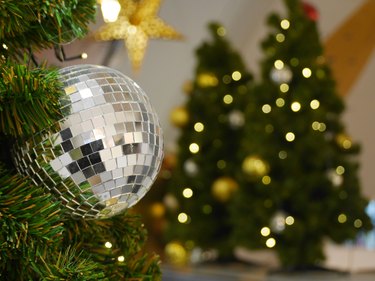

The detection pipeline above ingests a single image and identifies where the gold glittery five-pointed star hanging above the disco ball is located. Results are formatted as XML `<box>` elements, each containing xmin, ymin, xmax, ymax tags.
<box><xmin>95</xmin><ymin>0</ymin><xmax>182</xmax><ymax>70</ymax></box>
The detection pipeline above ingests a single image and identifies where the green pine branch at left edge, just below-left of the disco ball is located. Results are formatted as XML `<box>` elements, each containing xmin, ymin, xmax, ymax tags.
<box><xmin>0</xmin><ymin>164</ymin><xmax>63</xmax><ymax>280</ymax></box>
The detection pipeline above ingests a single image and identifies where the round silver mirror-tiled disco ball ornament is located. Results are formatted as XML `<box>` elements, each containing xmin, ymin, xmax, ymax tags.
<box><xmin>13</xmin><ymin>65</ymin><xmax>163</xmax><ymax>219</ymax></box>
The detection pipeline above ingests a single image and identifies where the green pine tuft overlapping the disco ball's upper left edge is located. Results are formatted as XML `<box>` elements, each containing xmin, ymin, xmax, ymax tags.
<box><xmin>0</xmin><ymin>61</ymin><xmax>63</xmax><ymax>138</ymax></box>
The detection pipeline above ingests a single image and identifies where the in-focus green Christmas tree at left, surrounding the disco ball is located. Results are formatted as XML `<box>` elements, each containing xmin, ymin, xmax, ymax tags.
<box><xmin>0</xmin><ymin>0</ymin><xmax>160</xmax><ymax>280</ymax></box>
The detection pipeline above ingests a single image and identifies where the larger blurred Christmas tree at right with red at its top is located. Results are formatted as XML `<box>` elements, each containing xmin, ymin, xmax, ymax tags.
<box><xmin>230</xmin><ymin>0</ymin><xmax>371</xmax><ymax>267</ymax></box>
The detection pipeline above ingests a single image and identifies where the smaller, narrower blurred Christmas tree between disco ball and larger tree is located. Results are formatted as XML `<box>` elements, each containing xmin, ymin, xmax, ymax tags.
<box><xmin>164</xmin><ymin>23</ymin><xmax>252</xmax><ymax>259</ymax></box>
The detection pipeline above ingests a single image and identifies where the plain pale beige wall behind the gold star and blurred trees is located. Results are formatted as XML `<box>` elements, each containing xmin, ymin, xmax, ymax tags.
<box><xmin>39</xmin><ymin>0</ymin><xmax>375</xmax><ymax>199</ymax></box>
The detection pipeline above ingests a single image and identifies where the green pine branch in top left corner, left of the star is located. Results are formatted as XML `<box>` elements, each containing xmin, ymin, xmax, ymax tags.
<box><xmin>0</xmin><ymin>0</ymin><xmax>96</xmax><ymax>58</ymax></box>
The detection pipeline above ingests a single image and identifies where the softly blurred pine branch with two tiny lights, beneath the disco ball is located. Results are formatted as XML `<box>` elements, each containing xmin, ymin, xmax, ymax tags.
<box><xmin>64</xmin><ymin>213</ymin><xmax>161</xmax><ymax>281</ymax></box>
